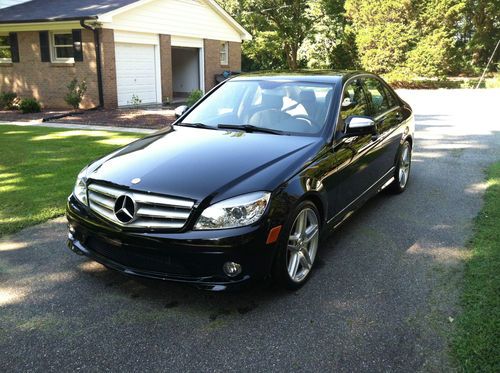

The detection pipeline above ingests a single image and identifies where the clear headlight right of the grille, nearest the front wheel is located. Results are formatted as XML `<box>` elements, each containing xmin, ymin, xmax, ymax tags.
<box><xmin>194</xmin><ymin>192</ymin><xmax>271</xmax><ymax>229</ymax></box>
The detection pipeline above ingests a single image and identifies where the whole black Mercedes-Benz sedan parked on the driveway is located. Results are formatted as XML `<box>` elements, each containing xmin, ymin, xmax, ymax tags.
<box><xmin>67</xmin><ymin>71</ymin><xmax>414</xmax><ymax>290</ymax></box>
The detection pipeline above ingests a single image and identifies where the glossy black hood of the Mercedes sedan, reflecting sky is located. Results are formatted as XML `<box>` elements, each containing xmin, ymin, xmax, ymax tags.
<box><xmin>87</xmin><ymin>126</ymin><xmax>323</xmax><ymax>202</ymax></box>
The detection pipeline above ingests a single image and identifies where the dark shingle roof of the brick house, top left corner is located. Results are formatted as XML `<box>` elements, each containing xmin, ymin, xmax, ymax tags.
<box><xmin>0</xmin><ymin>0</ymin><xmax>138</xmax><ymax>23</ymax></box>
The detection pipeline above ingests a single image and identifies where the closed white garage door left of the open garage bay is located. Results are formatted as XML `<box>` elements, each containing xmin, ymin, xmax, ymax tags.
<box><xmin>115</xmin><ymin>43</ymin><xmax>160</xmax><ymax>106</ymax></box>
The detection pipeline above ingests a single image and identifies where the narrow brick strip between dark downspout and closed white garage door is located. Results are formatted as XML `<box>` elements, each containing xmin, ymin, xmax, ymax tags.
<box><xmin>99</xmin><ymin>29</ymin><xmax>118</xmax><ymax>108</ymax></box>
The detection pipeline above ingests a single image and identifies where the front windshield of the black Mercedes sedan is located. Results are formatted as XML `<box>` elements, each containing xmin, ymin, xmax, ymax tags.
<box><xmin>182</xmin><ymin>80</ymin><xmax>334</xmax><ymax>134</ymax></box>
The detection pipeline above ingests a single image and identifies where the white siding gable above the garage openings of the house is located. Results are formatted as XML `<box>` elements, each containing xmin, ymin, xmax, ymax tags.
<box><xmin>104</xmin><ymin>0</ymin><xmax>241</xmax><ymax>42</ymax></box>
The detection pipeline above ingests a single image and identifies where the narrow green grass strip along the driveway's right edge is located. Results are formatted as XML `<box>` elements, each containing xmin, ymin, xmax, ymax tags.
<box><xmin>452</xmin><ymin>162</ymin><xmax>500</xmax><ymax>372</ymax></box>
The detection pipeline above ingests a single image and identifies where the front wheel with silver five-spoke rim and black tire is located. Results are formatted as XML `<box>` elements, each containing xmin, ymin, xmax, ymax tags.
<box><xmin>272</xmin><ymin>201</ymin><xmax>321</xmax><ymax>290</ymax></box>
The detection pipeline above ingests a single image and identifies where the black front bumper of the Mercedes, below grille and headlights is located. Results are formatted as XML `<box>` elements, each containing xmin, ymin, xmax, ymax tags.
<box><xmin>66</xmin><ymin>196</ymin><xmax>276</xmax><ymax>290</ymax></box>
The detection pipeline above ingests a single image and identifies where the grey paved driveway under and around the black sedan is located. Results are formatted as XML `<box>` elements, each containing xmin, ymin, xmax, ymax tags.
<box><xmin>0</xmin><ymin>90</ymin><xmax>500</xmax><ymax>372</ymax></box>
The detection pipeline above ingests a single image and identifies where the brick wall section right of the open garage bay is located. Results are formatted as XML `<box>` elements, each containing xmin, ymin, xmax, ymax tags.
<box><xmin>204</xmin><ymin>39</ymin><xmax>241</xmax><ymax>91</ymax></box>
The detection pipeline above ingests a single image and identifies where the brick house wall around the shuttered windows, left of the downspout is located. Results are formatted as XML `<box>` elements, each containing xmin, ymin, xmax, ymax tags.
<box><xmin>0</xmin><ymin>30</ymin><xmax>99</xmax><ymax>108</ymax></box>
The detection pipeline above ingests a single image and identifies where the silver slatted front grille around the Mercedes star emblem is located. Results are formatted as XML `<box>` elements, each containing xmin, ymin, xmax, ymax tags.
<box><xmin>88</xmin><ymin>184</ymin><xmax>194</xmax><ymax>229</ymax></box>
